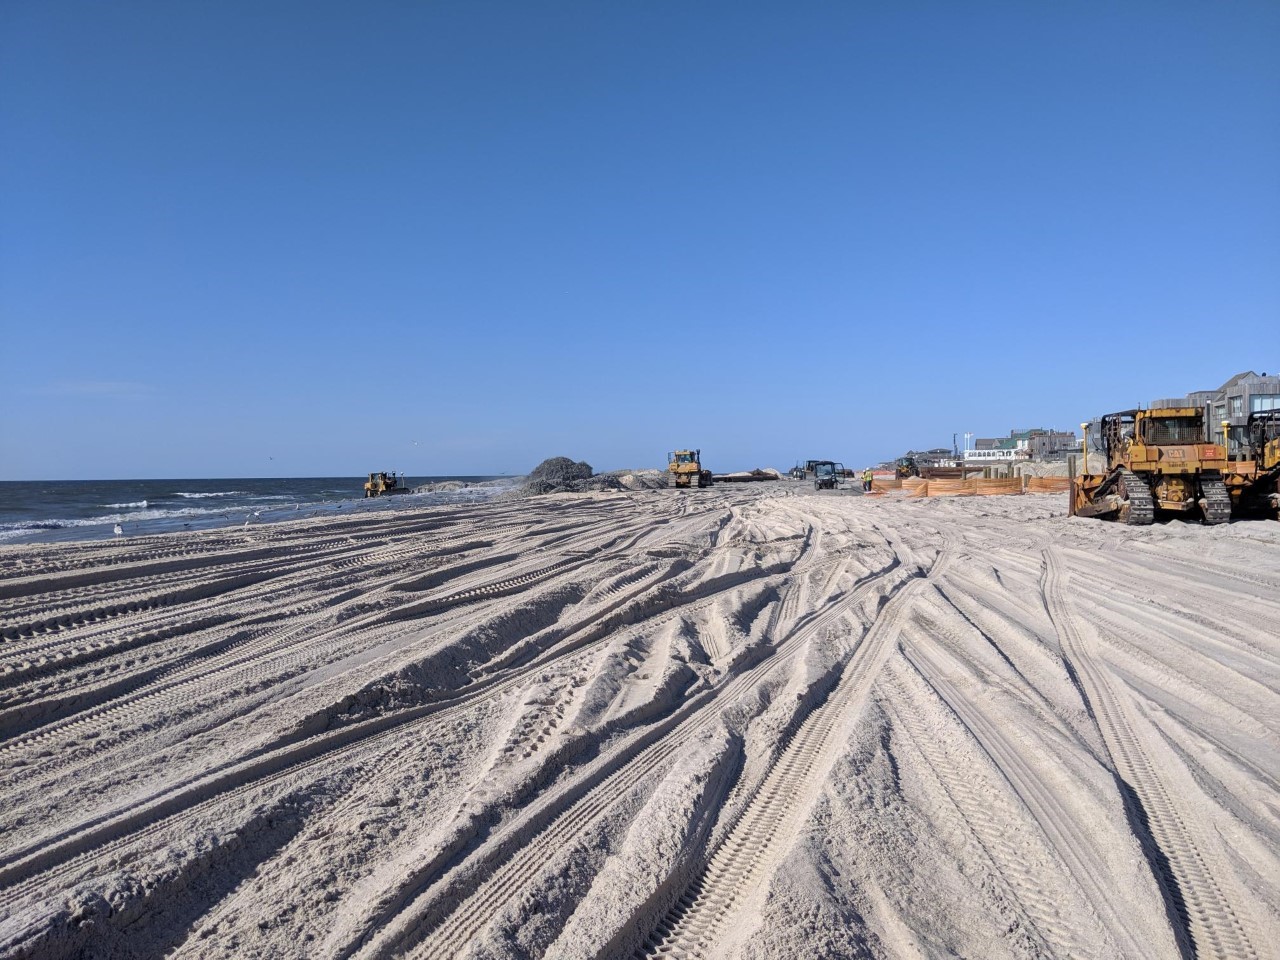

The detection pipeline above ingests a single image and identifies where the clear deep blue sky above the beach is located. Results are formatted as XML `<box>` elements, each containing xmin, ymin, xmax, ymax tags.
<box><xmin>0</xmin><ymin>0</ymin><xmax>1280</xmax><ymax>479</ymax></box>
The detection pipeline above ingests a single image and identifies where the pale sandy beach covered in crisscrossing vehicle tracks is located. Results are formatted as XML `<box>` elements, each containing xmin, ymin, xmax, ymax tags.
<box><xmin>0</xmin><ymin>483</ymin><xmax>1280</xmax><ymax>960</ymax></box>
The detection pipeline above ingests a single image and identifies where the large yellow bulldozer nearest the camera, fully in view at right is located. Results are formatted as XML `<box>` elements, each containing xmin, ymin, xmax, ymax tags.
<box><xmin>1069</xmin><ymin>407</ymin><xmax>1231</xmax><ymax>526</ymax></box>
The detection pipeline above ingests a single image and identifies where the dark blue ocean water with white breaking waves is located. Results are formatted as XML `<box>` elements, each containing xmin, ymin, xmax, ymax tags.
<box><xmin>0</xmin><ymin>476</ymin><xmax>520</xmax><ymax>545</ymax></box>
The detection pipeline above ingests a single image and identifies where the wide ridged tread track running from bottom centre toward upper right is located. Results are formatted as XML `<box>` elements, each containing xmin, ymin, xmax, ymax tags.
<box><xmin>636</xmin><ymin>545</ymin><xmax>951</xmax><ymax>957</ymax></box>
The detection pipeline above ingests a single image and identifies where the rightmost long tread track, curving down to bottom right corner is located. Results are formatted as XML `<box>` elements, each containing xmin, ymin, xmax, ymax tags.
<box><xmin>1043</xmin><ymin>548</ymin><xmax>1258</xmax><ymax>957</ymax></box>
